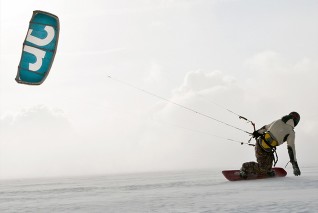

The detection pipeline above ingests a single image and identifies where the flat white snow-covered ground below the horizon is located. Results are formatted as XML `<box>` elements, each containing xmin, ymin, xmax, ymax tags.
<box><xmin>0</xmin><ymin>167</ymin><xmax>318</xmax><ymax>213</ymax></box>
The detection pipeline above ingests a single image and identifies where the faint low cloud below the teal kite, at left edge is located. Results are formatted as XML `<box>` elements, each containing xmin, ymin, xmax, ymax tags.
<box><xmin>0</xmin><ymin>105</ymin><xmax>75</xmax><ymax>178</ymax></box>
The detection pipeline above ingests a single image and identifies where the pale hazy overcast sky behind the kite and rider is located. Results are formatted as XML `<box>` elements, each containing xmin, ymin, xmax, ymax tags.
<box><xmin>0</xmin><ymin>0</ymin><xmax>318</xmax><ymax>179</ymax></box>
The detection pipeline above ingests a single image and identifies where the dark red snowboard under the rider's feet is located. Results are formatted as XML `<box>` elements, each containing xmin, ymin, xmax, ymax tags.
<box><xmin>222</xmin><ymin>167</ymin><xmax>287</xmax><ymax>181</ymax></box>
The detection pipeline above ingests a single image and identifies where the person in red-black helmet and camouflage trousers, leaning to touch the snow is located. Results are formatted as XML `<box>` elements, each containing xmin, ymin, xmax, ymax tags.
<box><xmin>240</xmin><ymin>112</ymin><xmax>301</xmax><ymax>178</ymax></box>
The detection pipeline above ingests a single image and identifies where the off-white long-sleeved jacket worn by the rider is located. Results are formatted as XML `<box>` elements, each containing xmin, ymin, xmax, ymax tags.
<box><xmin>258</xmin><ymin>119</ymin><xmax>297</xmax><ymax>161</ymax></box>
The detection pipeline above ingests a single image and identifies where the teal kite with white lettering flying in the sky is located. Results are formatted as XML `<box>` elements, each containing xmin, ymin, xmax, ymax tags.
<box><xmin>15</xmin><ymin>10</ymin><xmax>60</xmax><ymax>85</ymax></box>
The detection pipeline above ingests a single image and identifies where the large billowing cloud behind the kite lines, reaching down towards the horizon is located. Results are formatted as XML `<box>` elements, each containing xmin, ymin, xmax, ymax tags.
<box><xmin>142</xmin><ymin>70</ymin><xmax>253</xmax><ymax>169</ymax></box>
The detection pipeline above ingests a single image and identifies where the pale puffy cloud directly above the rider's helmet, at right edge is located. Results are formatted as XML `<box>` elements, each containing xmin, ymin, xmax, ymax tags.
<box><xmin>247</xmin><ymin>52</ymin><xmax>318</xmax><ymax>112</ymax></box>
